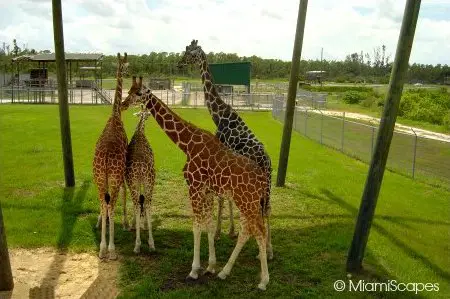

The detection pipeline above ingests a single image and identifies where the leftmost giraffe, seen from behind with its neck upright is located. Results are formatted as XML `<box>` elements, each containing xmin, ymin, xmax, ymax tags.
<box><xmin>92</xmin><ymin>53</ymin><xmax>128</xmax><ymax>260</ymax></box>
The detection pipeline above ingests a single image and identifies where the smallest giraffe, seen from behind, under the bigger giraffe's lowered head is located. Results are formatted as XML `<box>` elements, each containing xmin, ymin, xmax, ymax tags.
<box><xmin>125</xmin><ymin>111</ymin><xmax>155</xmax><ymax>253</ymax></box>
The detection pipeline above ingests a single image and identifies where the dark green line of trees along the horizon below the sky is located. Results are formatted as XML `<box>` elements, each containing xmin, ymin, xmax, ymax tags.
<box><xmin>0</xmin><ymin>40</ymin><xmax>450</xmax><ymax>84</ymax></box>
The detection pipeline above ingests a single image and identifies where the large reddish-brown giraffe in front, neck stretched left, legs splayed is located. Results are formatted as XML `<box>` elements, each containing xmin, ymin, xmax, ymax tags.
<box><xmin>125</xmin><ymin>77</ymin><xmax>269</xmax><ymax>290</ymax></box>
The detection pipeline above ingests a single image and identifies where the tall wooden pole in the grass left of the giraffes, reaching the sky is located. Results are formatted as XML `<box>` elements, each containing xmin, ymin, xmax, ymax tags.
<box><xmin>52</xmin><ymin>0</ymin><xmax>75</xmax><ymax>187</ymax></box>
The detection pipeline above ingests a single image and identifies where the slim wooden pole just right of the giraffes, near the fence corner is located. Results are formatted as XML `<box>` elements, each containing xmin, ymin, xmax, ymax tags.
<box><xmin>276</xmin><ymin>0</ymin><xmax>308</xmax><ymax>187</ymax></box>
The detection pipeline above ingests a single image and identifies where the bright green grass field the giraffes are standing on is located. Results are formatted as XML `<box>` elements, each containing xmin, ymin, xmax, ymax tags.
<box><xmin>0</xmin><ymin>105</ymin><xmax>450</xmax><ymax>298</ymax></box>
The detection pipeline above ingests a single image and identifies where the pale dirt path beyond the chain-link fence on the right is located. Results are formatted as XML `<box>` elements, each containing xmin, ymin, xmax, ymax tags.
<box><xmin>308</xmin><ymin>110</ymin><xmax>450</xmax><ymax>142</ymax></box>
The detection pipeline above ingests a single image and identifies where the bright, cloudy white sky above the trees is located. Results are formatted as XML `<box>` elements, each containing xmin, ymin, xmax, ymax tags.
<box><xmin>0</xmin><ymin>0</ymin><xmax>450</xmax><ymax>65</ymax></box>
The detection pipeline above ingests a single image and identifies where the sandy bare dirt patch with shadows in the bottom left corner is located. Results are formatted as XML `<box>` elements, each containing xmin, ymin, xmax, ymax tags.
<box><xmin>0</xmin><ymin>248</ymin><xmax>118</xmax><ymax>299</ymax></box>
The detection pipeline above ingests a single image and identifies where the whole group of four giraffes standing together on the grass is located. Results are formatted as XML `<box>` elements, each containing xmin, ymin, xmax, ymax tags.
<box><xmin>93</xmin><ymin>40</ymin><xmax>273</xmax><ymax>290</ymax></box>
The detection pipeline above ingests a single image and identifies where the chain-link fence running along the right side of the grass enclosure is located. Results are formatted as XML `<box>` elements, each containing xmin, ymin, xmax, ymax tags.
<box><xmin>272</xmin><ymin>96</ymin><xmax>450</xmax><ymax>186</ymax></box>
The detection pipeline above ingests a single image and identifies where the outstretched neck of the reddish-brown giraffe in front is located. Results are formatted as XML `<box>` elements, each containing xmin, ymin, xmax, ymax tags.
<box><xmin>144</xmin><ymin>93</ymin><xmax>197</xmax><ymax>154</ymax></box>
